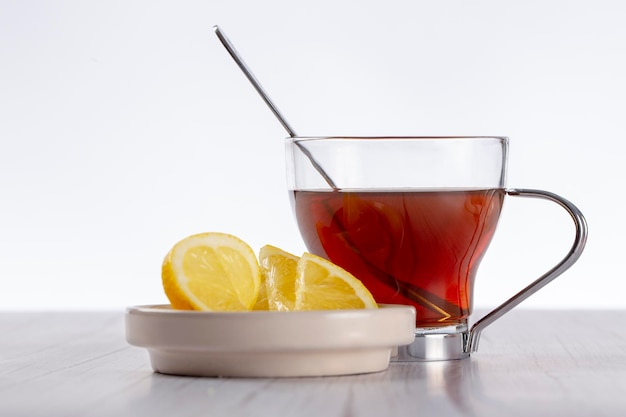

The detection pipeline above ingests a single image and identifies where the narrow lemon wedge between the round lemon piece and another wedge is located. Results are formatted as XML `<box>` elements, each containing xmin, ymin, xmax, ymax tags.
<box><xmin>259</xmin><ymin>245</ymin><xmax>300</xmax><ymax>311</ymax></box>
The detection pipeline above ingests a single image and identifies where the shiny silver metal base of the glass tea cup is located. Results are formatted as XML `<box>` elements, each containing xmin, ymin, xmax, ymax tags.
<box><xmin>391</xmin><ymin>323</ymin><xmax>470</xmax><ymax>362</ymax></box>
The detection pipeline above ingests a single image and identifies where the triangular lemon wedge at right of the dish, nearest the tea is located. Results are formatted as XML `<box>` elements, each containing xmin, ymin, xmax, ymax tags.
<box><xmin>295</xmin><ymin>253</ymin><xmax>378</xmax><ymax>310</ymax></box>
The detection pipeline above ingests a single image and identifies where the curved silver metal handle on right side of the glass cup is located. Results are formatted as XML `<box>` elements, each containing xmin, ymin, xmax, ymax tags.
<box><xmin>464</xmin><ymin>189</ymin><xmax>587</xmax><ymax>352</ymax></box>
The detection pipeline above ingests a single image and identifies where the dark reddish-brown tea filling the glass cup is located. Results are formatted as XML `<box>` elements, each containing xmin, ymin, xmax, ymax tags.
<box><xmin>294</xmin><ymin>189</ymin><xmax>505</xmax><ymax>327</ymax></box>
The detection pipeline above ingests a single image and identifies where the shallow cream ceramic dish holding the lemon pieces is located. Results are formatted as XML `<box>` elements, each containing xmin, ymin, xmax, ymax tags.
<box><xmin>126</xmin><ymin>305</ymin><xmax>415</xmax><ymax>377</ymax></box>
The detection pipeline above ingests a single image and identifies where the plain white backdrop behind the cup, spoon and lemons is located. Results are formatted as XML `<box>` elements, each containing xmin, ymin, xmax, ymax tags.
<box><xmin>0</xmin><ymin>0</ymin><xmax>626</xmax><ymax>309</ymax></box>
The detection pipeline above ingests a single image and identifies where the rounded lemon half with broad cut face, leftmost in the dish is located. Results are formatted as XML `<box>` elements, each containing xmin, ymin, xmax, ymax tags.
<box><xmin>162</xmin><ymin>232</ymin><xmax>261</xmax><ymax>311</ymax></box>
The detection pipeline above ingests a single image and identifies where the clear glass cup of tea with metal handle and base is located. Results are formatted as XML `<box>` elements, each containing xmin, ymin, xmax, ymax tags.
<box><xmin>286</xmin><ymin>137</ymin><xmax>587</xmax><ymax>360</ymax></box>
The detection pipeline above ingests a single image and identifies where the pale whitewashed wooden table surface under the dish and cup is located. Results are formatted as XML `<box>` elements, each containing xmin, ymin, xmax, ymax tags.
<box><xmin>0</xmin><ymin>310</ymin><xmax>626</xmax><ymax>417</ymax></box>
